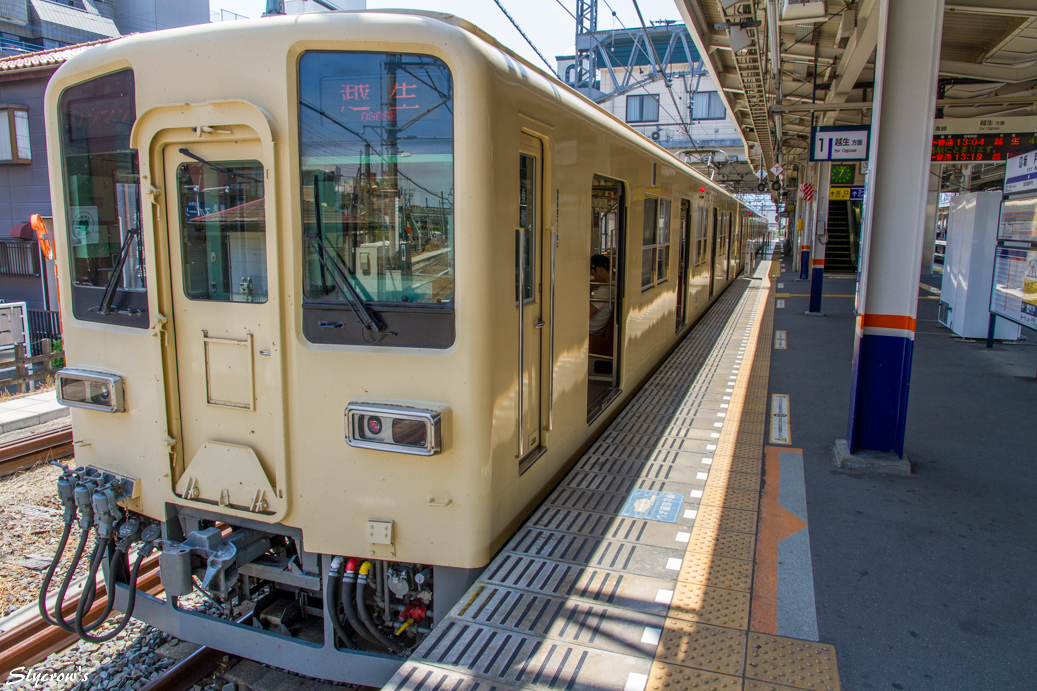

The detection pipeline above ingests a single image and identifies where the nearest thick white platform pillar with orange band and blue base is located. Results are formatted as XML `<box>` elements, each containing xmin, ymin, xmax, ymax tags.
<box><xmin>847</xmin><ymin>0</ymin><xmax>944</xmax><ymax>459</ymax></box>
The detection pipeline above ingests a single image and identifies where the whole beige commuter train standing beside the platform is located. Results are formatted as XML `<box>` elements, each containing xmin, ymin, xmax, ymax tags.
<box><xmin>40</xmin><ymin>11</ymin><xmax>766</xmax><ymax>684</ymax></box>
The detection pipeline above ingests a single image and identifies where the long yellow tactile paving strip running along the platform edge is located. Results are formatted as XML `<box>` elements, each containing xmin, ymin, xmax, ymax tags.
<box><xmin>646</xmin><ymin>261</ymin><xmax>839</xmax><ymax>691</ymax></box>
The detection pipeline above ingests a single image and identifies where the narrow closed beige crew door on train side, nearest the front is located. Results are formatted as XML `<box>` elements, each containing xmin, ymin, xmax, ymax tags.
<box><xmin>515</xmin><ymin>134</ymin><xmax>544</xmax><ymax>459</ymax></box>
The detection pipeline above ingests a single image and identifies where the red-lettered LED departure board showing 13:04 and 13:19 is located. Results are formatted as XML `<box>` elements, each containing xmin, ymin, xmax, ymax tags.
<box><xmin>929</xmin><ymin>117</ymin><xmax>1037</xmax><ymax>163</ymax></box>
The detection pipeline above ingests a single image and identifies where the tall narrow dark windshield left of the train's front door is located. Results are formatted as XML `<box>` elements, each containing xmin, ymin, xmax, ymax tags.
<box><xmin>58</xmin><ymin>70</ymin><xmax>148</xmax><ymax>329</ymax></box>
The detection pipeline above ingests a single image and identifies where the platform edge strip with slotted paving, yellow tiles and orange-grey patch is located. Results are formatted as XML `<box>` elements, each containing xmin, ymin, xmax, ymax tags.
<box><xmin>385</xmin><ymin>250</ymin><xmax>840</xmax><ymax>691</ymax></box>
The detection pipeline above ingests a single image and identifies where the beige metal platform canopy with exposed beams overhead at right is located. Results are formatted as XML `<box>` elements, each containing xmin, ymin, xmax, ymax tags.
<box><xmin>675</xmin><ymin>0</ymin><xmax>1037</xmax><ymax>185</ymax></box>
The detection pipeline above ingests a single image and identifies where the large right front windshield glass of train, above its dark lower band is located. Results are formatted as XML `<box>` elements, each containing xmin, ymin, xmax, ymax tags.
<box><xmin>299</xmin><ymin>52</ymin><xmax>454</xmax><ymax>304</ymax></box>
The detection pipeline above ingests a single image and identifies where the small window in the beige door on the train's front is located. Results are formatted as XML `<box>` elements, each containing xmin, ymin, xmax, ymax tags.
<box><xmin>176</xmin><ymin>161</ymin><xmax>268</xmax><ymax>302</ymax></box>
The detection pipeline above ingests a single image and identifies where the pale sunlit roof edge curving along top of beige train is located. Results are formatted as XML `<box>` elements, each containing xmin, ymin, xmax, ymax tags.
<box><xmin>55</xmin><ymin>9</ymin><xmax>748</xmax><ymax>209</ymax></box>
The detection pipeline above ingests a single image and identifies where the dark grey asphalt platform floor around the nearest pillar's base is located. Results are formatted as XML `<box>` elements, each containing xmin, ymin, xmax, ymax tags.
<box><xmin>770</xmin><ymin>257</ymin><xmax>1037</xmax><ymax>691</ymax></box>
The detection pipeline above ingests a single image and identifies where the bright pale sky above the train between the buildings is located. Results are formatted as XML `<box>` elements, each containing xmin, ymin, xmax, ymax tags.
<box><xmin>208</xmin><ymin>0</ymin><xmax>680</xmax><ymax>70</ymax></box>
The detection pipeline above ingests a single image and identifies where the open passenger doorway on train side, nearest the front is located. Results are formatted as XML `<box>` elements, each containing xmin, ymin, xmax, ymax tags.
<box><xmin>587</xmin><ymin>175</ymin><xmax>626</xmax><ymax>422</ymax></box>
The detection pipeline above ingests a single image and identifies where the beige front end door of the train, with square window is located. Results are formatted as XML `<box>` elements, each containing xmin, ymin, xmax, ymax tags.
<box><xmin>163</xmin><ymin>139</ymin><xmax>285</xmax><ymax>514</ymax></box>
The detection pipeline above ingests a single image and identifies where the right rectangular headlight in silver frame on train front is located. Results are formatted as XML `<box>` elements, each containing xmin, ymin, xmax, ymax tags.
<box><xmin>345</xmin><ymin>403</ymin><xmax>443</xmax><ymax>455</ymax></box>
